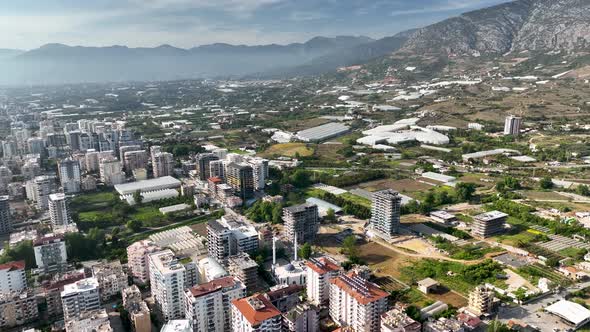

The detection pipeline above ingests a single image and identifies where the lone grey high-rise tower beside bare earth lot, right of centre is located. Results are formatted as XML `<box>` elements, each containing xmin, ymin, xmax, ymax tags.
<box><xmin>371</xmin><ymin>189</ymin><xmax>402</xmax><ymax>238</ymax></box>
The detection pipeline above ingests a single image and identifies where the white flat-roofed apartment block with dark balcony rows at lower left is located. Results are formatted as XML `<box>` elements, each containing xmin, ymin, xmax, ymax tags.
<box><xmin>61</xmin><ymin>278</ymin><xmax>100</xmax><ymax>320</ymax></box>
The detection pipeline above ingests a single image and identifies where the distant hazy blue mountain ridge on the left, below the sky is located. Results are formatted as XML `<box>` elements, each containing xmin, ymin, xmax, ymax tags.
<box><xmin>0</xmin><ymin>36</ymin><xmax>373</xmax><ymax>84</ymax></box>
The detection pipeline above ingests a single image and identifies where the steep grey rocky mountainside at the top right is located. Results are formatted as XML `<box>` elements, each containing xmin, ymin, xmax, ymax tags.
<box><xmin>403</xmin><ymin>0</ymin><xmax>590</xmax><ymax>55</ymax></box>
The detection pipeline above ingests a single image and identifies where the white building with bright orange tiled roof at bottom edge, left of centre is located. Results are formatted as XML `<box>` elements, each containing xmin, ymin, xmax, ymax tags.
<box><xmin>231</xmin><ymin>294</ymin><xmax>282</xmax><ymax>332</ymax></box>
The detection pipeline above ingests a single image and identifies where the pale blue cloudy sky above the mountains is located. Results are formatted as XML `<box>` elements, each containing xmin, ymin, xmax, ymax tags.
<box><xmin>0</xmin><ymin>0</ymin><xmax>507</xmax><ymax>49</ymax></box>
